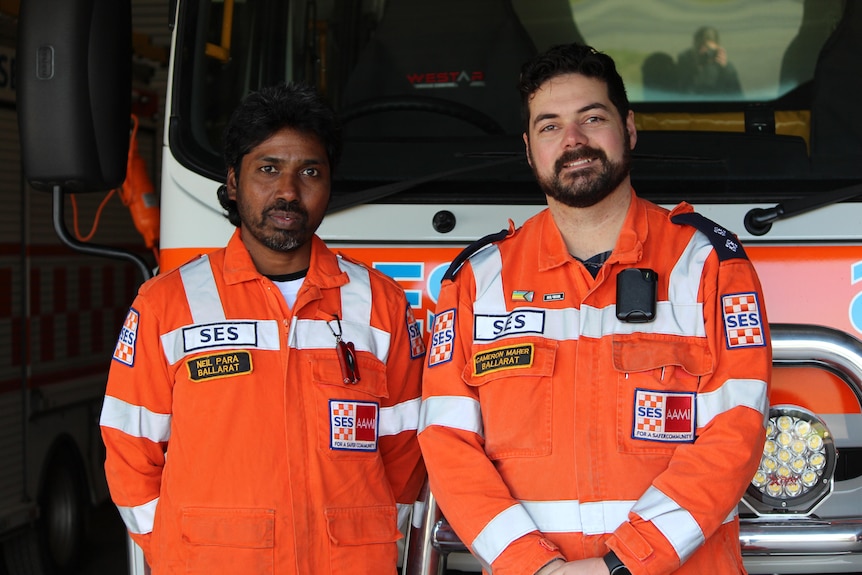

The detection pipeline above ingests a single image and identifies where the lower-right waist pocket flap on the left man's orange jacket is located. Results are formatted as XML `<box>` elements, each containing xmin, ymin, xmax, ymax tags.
<box><xmin>326</xmin><ymin>506</ymin><xmax>401</xmax><ymax>546</ymax></box>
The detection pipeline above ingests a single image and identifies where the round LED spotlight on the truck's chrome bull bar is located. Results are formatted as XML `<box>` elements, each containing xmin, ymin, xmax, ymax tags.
<box><xmin>743</xmin><ymin>405</ymin><xmax>837</xmax><ymax>515</ymax></box>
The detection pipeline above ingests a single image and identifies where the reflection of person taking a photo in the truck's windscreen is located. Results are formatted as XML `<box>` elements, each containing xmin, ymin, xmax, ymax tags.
<box><xmin>677</xmin><ymin>26</ymin><xmax>742</xmax><ymax>95</ymax></box>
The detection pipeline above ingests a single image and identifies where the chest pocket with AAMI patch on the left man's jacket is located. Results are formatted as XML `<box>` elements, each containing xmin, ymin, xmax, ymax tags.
<box><xmin>306</xmin><ymin>349</ymin><xmax>389</xmax><ymax>459</ymax></box>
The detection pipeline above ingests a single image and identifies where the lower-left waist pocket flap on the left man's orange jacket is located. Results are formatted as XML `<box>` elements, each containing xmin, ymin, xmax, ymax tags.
<box><xmin>182</xmin><ymin>508</ymin><xmax>275</xmax><ymax>549</ymax></box>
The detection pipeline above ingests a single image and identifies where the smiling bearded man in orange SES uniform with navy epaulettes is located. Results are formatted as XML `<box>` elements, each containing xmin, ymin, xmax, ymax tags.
<box><xmin>419</xmin><ymin>45</ymin><xmax>772</xmax><ymax>575</ymax></box>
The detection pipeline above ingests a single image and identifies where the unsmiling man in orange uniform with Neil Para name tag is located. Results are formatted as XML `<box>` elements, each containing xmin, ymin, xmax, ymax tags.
<box><xmin>101</xmin><ymin>85</ymin><xmax>425</xmax><ymax>575</ymax></box>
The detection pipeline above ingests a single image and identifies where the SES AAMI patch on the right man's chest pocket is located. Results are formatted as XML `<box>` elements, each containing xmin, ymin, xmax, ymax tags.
<box><xmin>632</xmin><ymin>389</ymin><xmax>697</xmax><ymax>442</ymax></box>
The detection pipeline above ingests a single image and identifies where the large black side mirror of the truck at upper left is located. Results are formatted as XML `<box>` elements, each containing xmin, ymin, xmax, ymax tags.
<box><xmin>17</xmin><ymin>0</ymin><xmax>132</xmax><ymax>192</ymax></box>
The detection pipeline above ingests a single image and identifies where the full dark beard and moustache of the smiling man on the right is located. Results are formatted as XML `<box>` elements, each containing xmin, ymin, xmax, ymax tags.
<box><xmin>533</xmin><ymin>140</ymin><xmax>631</xmax><ymax>208</ymax></box>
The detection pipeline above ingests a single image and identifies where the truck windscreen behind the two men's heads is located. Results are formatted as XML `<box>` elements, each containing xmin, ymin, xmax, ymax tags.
<box><xmin>170</xmin><ymin>0</ymin><xmax>859</xmax><ymax>205</ymax></box>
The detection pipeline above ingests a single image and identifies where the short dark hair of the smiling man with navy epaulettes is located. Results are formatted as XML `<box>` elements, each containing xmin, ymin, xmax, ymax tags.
<box><xmin>518</xmin><ymin>43</ymin><xmax>630</xmax><ymax>133</ymax></box>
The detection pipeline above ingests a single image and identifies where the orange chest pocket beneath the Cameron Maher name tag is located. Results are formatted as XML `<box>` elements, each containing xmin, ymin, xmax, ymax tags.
<box><xmin>462</xmin><ymin>338</ymin><xmax>557</xmax><ymax>459</ymax></box>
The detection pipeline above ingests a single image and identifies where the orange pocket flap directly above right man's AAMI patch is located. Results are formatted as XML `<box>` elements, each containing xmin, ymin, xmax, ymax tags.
<box><xmin>613</xmin><ymin>334</ymin><xmax>713</xmax><ymax>376</ymax></box>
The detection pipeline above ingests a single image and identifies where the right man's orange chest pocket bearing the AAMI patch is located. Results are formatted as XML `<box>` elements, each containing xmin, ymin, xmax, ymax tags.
<box><xmin>613</xmin><ymin>334</ymin><xmax>713</xmax><ymax>456</ymax></box>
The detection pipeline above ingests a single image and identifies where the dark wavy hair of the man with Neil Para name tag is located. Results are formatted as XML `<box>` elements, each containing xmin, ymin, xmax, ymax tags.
<box><xmin>218</xmin><ymin>83</ymin><xmax>341</xmax><ymax>227</ymax></box>
